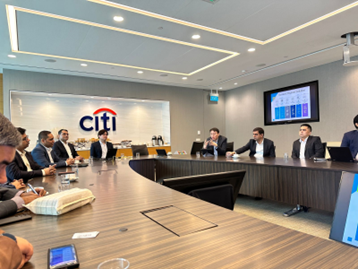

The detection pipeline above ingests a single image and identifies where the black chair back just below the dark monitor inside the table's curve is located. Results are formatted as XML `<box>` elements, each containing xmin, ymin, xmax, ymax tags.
<box><xmin>188</xmin><ymin>184</ymin><xmax>234</xmax><ymax>210</ymax></box>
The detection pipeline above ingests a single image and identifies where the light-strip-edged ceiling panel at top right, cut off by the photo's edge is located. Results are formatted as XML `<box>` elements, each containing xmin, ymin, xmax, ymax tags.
<box><xmin>87</xmin><ymin>0</ymin><xmax>358</xmax><ymax>45</ymax></box>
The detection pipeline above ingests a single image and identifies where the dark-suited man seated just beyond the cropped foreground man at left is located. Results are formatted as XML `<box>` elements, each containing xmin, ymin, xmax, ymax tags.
<box><xmin>6</xmin><ymin>128</ymin><xmax>56</xmax><ymax>184</ymax></box>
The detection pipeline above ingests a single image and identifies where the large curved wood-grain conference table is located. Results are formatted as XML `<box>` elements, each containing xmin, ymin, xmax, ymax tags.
<box><xmin>1</xmin><ymin>156</ymin><xmax>358</xmax><ymax>269</ymax></box>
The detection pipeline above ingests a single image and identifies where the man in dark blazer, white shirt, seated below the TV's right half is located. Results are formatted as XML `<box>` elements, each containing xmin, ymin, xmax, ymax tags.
<box><xmin>292</xmin><ymin>124</ymin><xmax>325</xmax><ymax>159</ymax></box>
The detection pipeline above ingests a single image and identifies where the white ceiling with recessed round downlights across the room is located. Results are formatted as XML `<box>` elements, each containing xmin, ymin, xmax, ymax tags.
<box><xmin>0</xmin><ymin>0</ymin><xmax>358</xmax><ymax>90</ymax></box>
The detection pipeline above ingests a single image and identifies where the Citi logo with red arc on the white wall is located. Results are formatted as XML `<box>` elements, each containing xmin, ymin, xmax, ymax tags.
<box><xmin>80</xmin><ymin>108</ymin><xmax>117</xmax><ymax>132</ymax></box>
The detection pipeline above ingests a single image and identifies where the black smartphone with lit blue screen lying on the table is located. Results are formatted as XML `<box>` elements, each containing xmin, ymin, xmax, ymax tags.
<box><xmin>48</xmin><ymin>245</ymin><xmax>80</xmax><ymax>269</ymax></box>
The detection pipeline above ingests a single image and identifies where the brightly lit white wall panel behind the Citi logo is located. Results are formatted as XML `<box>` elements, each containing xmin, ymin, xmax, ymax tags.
<box><xmin>11</xmin><ymin>92</ymin><xmax>171</xmax><ymax>150</ymax></box>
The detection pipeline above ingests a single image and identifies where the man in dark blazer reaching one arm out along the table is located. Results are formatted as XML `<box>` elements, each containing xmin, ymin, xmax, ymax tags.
<box><xmin>227</xmin><ymin>128</ymin><xmax>275</xmax><ymax>158</ymax></box>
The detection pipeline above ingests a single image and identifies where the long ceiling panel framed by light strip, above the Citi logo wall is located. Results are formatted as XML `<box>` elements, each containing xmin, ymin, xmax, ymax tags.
<box><xmin>7</xmin><ymin>7</ymin><xmax>239</xmax><ymax>76</ymax></box>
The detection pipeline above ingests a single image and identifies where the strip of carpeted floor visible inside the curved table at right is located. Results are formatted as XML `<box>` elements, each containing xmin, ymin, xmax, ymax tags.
<box><xmin>234</xmin><ymin>196</ymin><xmax>333</xmax><ymax>240</ymax></box>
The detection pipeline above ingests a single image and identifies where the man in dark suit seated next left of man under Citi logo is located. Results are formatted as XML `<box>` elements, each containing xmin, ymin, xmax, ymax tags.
<box><xmin>52</xmin><ymin>129</ymin><xmax>84</xmax><ymax>162</ymax></box>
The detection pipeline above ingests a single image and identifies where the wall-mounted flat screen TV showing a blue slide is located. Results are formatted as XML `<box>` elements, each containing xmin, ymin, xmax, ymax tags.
<box><xmin>264</xmin><ymin>81</ymin><xmax>320</xmax><ymax>125</ymax></box>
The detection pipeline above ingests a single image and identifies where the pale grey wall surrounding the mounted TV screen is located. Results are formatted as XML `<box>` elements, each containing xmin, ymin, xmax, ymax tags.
<box><xmin>225</xmin><ymin>58</ymin><xmax>358</xmax><ymax>157</ymax></box>
